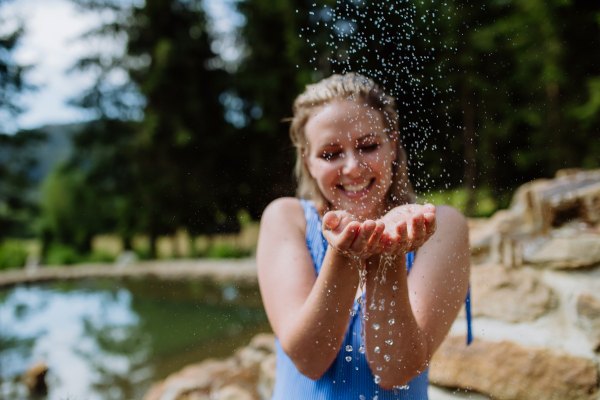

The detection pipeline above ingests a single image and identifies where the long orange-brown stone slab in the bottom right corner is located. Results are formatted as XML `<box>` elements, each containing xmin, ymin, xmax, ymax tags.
<box><xmin>429</xmin><ymin>336</ymin><xmax>598</xmax><ymax>400</ymax></box>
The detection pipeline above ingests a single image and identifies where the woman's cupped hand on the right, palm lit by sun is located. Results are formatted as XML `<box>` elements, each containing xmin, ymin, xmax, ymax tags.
<box><xmin>378</xmin><ymin>204</ymin><xmax>437</xmax><ymax>254</ymax></box>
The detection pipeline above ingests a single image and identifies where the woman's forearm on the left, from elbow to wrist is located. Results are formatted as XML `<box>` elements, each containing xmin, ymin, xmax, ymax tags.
<box><xmin>279</xmin><ymin>248</ymin><xmax>358</xmax><ymax>379</ymax></box>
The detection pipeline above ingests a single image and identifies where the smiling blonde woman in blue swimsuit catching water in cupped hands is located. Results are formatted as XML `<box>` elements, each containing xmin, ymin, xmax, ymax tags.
<box><xmin>257</xmin><ymin>74</ymin><xmax>469</xmax><ymax>400</ymax></box>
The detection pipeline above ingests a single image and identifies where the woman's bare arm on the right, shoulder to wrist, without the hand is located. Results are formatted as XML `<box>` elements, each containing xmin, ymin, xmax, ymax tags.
<box><xmin>366</xmin><ymin>207</ymin><xmax>470</xmax><ymax>389</ymax></box>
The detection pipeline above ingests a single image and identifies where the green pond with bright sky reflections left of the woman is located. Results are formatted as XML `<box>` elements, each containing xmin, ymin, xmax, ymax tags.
<box><xmin>0</xmin><ymin>279</ymin><xmax>270</xmax><ymax>400</ymax></box>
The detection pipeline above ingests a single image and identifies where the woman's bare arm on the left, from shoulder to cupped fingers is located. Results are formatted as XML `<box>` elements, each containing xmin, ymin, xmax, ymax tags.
<box><xmin>257</xmin><ymin>199</ymin><xmax>383</xmax><ymax>379</ymax></box>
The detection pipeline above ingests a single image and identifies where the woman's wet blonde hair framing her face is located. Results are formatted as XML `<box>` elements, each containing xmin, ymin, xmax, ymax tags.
<box><xmin>289</xmin><ymin>72</ymin><xmax>416</xmax><ymax>212</ymax></box>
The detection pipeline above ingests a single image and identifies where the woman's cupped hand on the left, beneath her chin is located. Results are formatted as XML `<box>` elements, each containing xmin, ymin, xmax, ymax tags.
<box><xmin>323</xmin><ymin>211</ymin><xmax>385</xmax><ymax>259</ymax></box>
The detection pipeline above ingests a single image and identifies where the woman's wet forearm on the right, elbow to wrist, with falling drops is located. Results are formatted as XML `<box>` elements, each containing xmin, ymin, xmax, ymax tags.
<box><xmin>365</xmin><ymin>255</ymin><xmax>428</xmax><ymax>389</ymax></box>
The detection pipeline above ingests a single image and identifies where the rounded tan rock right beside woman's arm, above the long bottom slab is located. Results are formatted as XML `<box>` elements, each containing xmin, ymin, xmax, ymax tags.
<box><xmin>471</xmin><ymin>264</ymin><xmax>556</xmax><ymax>322</ymax></box>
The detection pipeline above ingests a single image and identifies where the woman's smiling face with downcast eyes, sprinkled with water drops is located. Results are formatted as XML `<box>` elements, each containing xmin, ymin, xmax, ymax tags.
<box><xmin>305</xmin><ymin>100</ymin><xmax>396</xmax><ymax>218</ymax></box>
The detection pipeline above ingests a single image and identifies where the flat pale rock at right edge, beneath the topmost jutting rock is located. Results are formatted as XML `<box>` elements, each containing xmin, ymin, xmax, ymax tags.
<box><xmin>523</xmin><ymin>234</ymin><xmax>600</xmax><ymax>268</ymax></box>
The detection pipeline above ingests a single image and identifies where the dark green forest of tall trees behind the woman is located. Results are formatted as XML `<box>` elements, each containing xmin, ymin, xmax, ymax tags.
<box><xmin>0</xmin><ymin>0</ymin><xmax>600</xmax><ymax>262</ymax></box>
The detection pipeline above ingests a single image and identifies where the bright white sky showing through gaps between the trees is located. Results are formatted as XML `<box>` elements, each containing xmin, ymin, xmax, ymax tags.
<box><xmin>0</xmin><ymin>0</ymin><xmax>243</xmax><ymax>133</ymax></box>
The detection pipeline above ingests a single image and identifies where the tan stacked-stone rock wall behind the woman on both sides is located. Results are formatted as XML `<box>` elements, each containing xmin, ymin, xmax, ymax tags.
<box><xmin>146</xmin><ymin>170</ymin><xmax>600</xmax><ymax>400</ymax></box>
